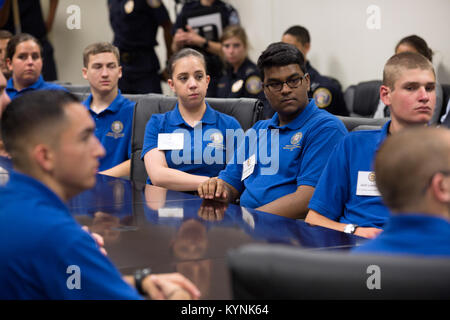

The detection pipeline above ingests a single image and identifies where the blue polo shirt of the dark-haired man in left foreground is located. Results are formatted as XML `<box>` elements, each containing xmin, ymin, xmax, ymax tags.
<box><xmin>0</xmin><ymin>171</ymin><xmax>141</xmax><ymax>300</ymax></box>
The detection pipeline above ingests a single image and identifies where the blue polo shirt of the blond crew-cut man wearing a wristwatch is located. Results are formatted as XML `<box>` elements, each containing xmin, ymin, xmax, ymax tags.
<box><xmin>309</xmin><ymin>121</ymin><xmax>390</xmax><ymax>228</ymax></box>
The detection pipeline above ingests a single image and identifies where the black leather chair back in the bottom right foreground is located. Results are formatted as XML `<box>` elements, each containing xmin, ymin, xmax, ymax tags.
<box><xmin>228</xmin><ymin>244</ymin><xmax>450</xmax><ymax>300</ymax></box>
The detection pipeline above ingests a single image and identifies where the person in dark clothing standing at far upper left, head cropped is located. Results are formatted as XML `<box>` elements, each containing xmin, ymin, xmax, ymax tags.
<box><xmin>0</xmin><ymin>0</ymin><xmax>58</xmax><ymax>81</ymax></box>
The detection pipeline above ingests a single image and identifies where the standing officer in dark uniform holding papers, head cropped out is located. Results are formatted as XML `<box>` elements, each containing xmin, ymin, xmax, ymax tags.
<box><xmin>172</xmin><ymin>0</ymin><xmax>239</xmax><ymax>97</ymax></box>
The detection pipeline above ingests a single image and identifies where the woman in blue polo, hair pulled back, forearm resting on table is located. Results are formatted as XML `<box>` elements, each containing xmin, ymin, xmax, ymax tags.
<box><xmin>141</xmin><ymin>48</ymin><xmax>240</xmax><ymax>191</ymax></box>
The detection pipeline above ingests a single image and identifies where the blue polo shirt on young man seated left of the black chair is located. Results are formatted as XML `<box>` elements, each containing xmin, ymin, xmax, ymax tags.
<box><xmin>83</xmin><ymin>90</ymin><xmax>135</xmax><ymax>171</ymax></box>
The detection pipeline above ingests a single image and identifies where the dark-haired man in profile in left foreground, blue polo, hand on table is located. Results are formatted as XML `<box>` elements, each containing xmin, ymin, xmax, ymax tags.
<box><xmin>0</xmin><ymin>90</ymin><xmax>199</xmax><ymax>300</ymax></box>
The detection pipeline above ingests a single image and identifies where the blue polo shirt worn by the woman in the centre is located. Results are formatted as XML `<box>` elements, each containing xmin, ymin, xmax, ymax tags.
<box><xmin>141</xmin><ymin>103</ymin><xmax>243</xmax><ymax>184</ymax></box>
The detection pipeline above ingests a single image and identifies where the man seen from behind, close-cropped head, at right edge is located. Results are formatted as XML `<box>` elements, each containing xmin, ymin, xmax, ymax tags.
<box><xmin>353</xmin><ymin>128</ymin><xmax>450</xmax><ymax>258</ymax></box>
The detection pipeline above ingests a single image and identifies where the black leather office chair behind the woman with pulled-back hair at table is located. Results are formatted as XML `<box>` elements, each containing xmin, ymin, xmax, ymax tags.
<box><xmin>126</xmin><ymin>94</ymin><xmax>263</xmax><ymax>182</ymax></box>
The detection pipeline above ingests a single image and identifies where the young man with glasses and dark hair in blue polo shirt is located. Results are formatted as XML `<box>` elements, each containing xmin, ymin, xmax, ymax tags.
<box><xmin>198</xmin><ymin>42</ymin><xmax>347</xmax><ymax>218</ymax></box>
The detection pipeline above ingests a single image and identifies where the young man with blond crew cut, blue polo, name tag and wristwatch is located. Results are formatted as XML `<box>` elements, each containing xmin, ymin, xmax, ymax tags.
<box><xmin>305</xmin><ymin>52</ymin><xmax>436</xmax><ymax>238</ymax></box>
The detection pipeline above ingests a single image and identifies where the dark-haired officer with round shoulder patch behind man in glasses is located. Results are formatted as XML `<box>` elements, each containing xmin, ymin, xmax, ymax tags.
<box><xmin>281</xmin><ymin>26</ymin><xmax>349</xmax><ymax>116</ymax></box>
